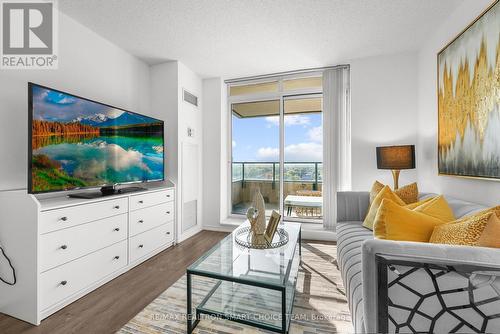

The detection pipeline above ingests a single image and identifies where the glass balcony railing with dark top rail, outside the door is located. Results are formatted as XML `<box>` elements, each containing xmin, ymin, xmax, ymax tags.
<box><xmin>232</xmin><ymin>161</ymin><xmax>323</xmax><ymax>190</ymax></box>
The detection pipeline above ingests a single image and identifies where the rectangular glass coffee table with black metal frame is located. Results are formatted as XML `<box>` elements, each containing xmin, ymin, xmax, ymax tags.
<box><xmin>187</xmin><ymin>222</ymin><xmax>301</xmax><ymax>333</ymax></box>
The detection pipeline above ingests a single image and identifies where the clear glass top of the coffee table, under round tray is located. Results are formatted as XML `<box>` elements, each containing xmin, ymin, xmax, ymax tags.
<box><xmin>188</xmin><ymin>222</ymin><xmax>300</xmax><ymax>287</ymax></box>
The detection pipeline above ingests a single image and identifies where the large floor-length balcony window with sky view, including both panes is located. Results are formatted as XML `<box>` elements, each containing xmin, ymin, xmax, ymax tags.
<box><xmin>228</xmin><ymin>73</ymin><xmax>323</xmax><ymax>222</ymax></box>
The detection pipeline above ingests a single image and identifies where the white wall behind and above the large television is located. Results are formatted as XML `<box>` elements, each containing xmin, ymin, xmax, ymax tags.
<box><xmin>0</xmin><ymin>13</ymin><xmax>151</xmax><ymax>190</ymax></box>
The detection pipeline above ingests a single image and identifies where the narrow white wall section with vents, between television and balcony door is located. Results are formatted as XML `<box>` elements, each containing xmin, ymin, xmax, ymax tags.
<box><xmin>151</xmin><ymin>61</ymin><xmax>203</xmax><ymax>241</ymax></box>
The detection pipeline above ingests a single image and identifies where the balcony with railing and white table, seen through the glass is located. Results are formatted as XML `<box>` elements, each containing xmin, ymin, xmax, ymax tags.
<box><xmin>231</xmin><ymin>162</ymin><xmax>323</xmax><ymax>220</ymax></box>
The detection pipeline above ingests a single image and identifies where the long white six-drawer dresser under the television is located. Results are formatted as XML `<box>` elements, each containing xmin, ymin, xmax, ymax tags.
<box><xmin>0</xmin><ymin>182</ymin><xmax>176</xmax><ymax>324</ymax></box>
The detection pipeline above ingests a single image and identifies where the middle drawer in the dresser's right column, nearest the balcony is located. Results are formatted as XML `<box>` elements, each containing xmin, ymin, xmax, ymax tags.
<box><xmin>129</xmin><ymin>202</ymin><xmax>174</xmax><ymax>236</ymax></box>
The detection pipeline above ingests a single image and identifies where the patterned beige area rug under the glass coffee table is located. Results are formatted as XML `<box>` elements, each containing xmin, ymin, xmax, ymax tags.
<box><xmin>119</xmin><ymin>242</ymin><xmax>353</xmax><ymax>334</ymax></box>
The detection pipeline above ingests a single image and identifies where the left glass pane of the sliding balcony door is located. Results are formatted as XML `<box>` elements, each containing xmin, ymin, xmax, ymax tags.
<box><xmin>231</xmin><ymin>100</ymin><xmax>280</xmax><ymax>216</ymax></box>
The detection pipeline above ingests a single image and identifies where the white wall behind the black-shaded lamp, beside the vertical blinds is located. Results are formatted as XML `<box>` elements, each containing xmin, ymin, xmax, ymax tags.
<box><xmin>349</xmin><ymin>53</ymin><xmax>420</xmax><ymax>191</ymax></box>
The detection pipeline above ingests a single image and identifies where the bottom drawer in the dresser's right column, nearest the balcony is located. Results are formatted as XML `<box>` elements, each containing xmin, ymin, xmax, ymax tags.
<box><xmin>129</xmin><ymin>223</ymin><xmax>174</xmax><ymax>263</ymax></box>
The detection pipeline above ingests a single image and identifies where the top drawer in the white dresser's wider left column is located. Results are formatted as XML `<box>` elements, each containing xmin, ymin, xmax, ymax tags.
<box><xmin>40</xmin><ymin>198</ymin><xmax>128</xmax><ymax>234</ymax></box>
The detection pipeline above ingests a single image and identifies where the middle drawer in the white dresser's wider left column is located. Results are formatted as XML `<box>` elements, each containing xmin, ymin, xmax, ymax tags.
<box><xmin>40</xmin><ymin>214</ymin><xmax>127</xmax><ymax>271</ymax></box>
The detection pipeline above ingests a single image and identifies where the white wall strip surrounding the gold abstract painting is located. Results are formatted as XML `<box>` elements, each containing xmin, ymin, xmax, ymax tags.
<box><xmin>417</xmin><ymin>0</ymin><xmax>500</xmax><ymax>205</ymax></box>
